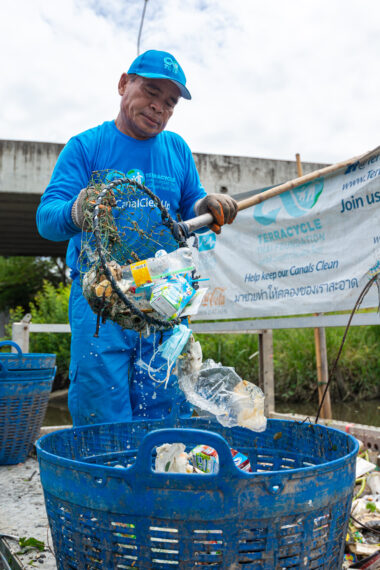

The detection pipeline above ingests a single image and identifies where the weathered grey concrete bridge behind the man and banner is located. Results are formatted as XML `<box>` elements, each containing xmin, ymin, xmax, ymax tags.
<box><xmin>0</xmin><ymin>140</ymin><xmax>324</xmax><ymax>257</ymax></box>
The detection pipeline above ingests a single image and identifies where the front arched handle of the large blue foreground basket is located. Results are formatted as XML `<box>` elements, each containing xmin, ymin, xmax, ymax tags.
<box><xmin>134</xmin><ymin>428</ymin><xmax>239</xmax><ymax>478</ymax></box>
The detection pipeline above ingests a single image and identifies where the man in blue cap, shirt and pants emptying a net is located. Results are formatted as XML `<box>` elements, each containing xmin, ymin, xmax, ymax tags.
<box><xmin>37</xmin><ymin>50</ymin><xmax>237</xmax><ymax>425</ymax></box>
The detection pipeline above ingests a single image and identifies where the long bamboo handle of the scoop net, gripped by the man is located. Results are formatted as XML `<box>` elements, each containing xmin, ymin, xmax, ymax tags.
<box><xmin>184</xmin><ymin>146</ymin><xmax>380</xmax><ymax>232</ymax></box>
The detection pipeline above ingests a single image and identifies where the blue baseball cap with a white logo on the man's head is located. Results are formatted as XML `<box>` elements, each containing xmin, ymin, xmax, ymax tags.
<box><xmin>128</xmin><ymin>49</ymin><xmax>191</xmax><ymax>99</ymax></box>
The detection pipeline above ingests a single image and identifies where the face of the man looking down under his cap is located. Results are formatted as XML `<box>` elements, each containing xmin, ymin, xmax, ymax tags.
<box><xmin>116</xmin><ymin>73</ymin><xmax>180</xmax><ymax>140</ymax></box>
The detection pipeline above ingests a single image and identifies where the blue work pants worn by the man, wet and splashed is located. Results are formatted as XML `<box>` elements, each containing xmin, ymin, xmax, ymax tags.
<box><xmin>69</xmin><ymin>279</ymin><xmax>191</xmax><ymax>426</ymax></box>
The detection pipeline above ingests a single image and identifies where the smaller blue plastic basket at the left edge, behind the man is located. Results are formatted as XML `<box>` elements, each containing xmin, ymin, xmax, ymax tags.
<box><xmin>0</xmin><ymin>341</ymin><xmax>56</xmax><ymax>465</ymax></box>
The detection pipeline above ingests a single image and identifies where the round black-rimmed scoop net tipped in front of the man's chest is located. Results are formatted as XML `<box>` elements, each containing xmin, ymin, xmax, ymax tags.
<box><xmin>79</xmin><ymin>171</ymin><xmax>194</xmax><ymax>335</ymax></box>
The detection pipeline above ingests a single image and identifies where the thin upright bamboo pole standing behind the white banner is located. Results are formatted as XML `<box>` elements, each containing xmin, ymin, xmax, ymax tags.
<box><xmin>296</xmin><ymin>152</ymin><xmax>332</xmax><ymax>420</ymax></box>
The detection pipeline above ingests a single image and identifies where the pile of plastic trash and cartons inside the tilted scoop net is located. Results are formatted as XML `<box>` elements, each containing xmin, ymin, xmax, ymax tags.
<box><xmin>82</xmin><ymin>247</ymin><xmax>207</xmax><ymax>334</ymax></box>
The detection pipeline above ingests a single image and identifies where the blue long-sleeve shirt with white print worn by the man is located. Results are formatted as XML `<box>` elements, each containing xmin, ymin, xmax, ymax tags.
<box><xmin>37</xmin><ymin>121</ymin><xmax>206</xmax><ymax>277</ymax></box>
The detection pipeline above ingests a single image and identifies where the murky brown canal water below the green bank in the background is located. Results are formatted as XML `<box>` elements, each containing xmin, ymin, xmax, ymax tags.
<box><xmin>43</xmin><ymin>393</ymin><xmax>380</xmax><ymax>427</ymax></box>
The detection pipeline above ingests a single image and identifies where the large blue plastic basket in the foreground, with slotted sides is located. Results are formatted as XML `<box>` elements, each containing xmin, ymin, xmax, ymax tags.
<box><xmin>37</xmin><ymin>412</ymin><xmax>358</xmax><ymax>570</ymax></box>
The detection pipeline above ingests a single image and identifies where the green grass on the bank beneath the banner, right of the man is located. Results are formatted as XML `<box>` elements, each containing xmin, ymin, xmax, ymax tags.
<box><xmin>196</xmin><ymin>326</ymin><xmax>380</xmax><ymax>402</ymax></box>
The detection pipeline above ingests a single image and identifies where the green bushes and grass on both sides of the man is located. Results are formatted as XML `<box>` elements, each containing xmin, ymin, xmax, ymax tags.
<box><xmin>1</xmin><ymin>281</ymin><xmax>380</xmax><ymax>402</ymax></box>
